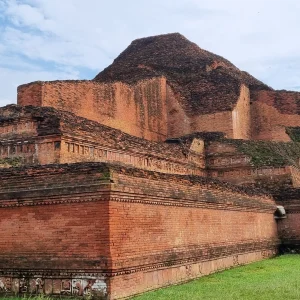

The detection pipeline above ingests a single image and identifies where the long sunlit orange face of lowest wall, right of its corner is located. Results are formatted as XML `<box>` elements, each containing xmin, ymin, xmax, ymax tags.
<box><xmin>106</xmin><ymin>169</ymin><xmax>277</xmax><ymax>298</ymax></box>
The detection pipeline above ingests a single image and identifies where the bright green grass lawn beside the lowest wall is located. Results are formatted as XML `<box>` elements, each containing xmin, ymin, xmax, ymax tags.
<box><xmin>132</xmin><ymin>255</ymin><xmax>300</xmax><ymax>300</ymax></box>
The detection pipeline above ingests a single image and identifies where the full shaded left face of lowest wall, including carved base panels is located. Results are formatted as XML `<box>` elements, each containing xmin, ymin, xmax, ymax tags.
<box><xmin>0</xmin><ymin>165</ymin><xmax>110</xmax><ymax>296</ymax></box>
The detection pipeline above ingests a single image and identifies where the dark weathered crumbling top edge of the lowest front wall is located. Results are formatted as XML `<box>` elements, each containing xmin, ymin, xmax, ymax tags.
<box><xmin>0</xmin><ymin>162</ymin><xmax>272</xmax><ymax>200</ymax></box>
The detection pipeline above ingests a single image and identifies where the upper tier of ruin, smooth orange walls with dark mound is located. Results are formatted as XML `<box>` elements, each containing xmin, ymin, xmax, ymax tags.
<box><xmin>18</xmin><ymin>33</ymin><xmax>300</xmax><ymax>142</ymax></box>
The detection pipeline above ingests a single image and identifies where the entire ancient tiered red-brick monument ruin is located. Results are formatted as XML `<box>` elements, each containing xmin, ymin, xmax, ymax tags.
<box><xmin>0</xmin><ymin>34</ymin><xmax>300</xmax><ymax>299</ymax></box>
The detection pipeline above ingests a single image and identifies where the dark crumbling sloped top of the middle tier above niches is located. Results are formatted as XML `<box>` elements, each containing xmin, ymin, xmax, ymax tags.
<box><xmin>0</xmin><ymin>105</ymin><xmax>191</xmax><ymax>160</ymax></box>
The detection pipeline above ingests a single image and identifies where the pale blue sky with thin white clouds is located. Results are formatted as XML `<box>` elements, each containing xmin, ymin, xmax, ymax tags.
<box><xmin>0</xmin><ymin>0</ymin><xmax>300</xmax><ymax>105</ymax></box>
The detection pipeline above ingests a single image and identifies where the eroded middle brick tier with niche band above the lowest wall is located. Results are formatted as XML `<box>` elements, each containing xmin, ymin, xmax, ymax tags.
<box><xmin>0</xmin><ymin>105</ymin><xmax>205</xmax><ymax>175</ymax></box>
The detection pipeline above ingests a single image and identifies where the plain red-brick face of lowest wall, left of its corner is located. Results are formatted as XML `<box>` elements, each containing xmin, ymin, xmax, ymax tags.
<box><xmin>0</xmin><ymin>199</ymin><xmax>109</xmax><ymax>270</ymax></box>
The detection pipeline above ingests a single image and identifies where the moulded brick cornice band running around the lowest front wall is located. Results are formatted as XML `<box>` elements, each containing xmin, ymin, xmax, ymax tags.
<box><xmin>0</xmin><ymin>190</ymin><xmax>276</xmax><ymax>214</ymax></box>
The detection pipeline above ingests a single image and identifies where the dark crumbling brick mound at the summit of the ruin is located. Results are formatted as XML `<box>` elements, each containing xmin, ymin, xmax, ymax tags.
<box><xmin>94</xmin><ymin>33</ymin><xmax>270</xmax><ymax>115</ymax></box>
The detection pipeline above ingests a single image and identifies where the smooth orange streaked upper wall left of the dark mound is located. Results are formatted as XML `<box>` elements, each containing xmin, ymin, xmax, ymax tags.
<box><xmin>18</xmin><ymin>78</ymin><xmax>167</xmax><ymax>141</ymax></box>
